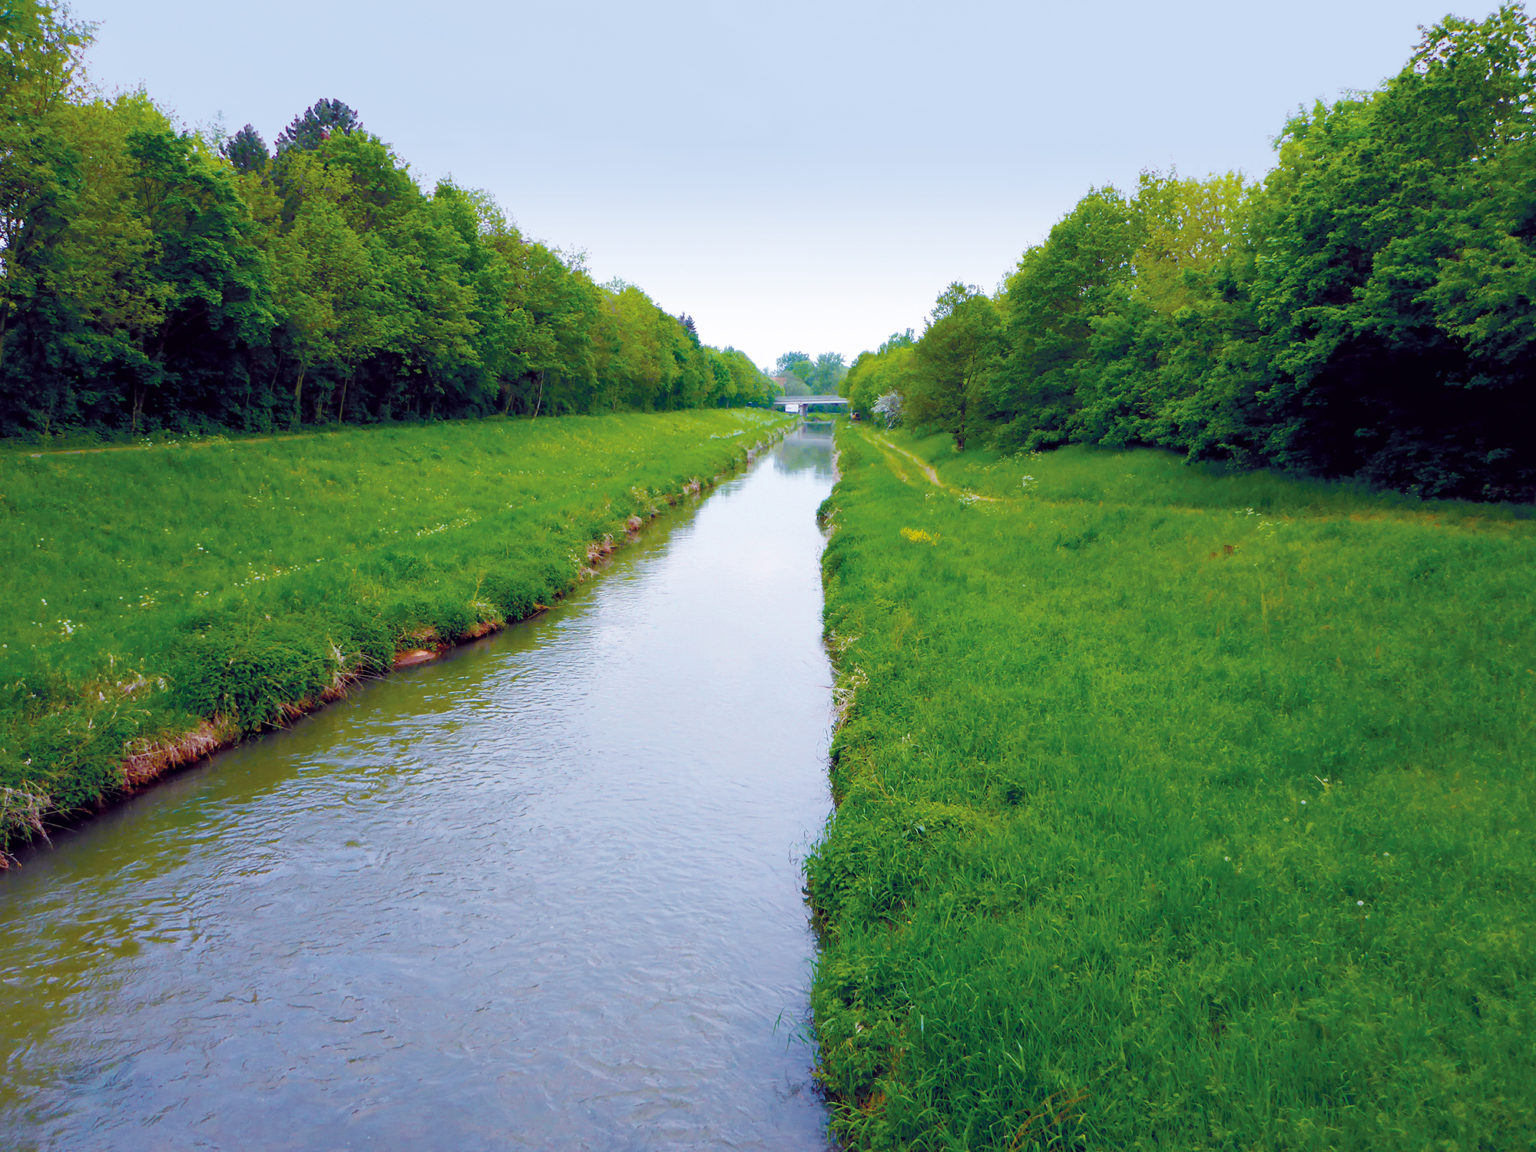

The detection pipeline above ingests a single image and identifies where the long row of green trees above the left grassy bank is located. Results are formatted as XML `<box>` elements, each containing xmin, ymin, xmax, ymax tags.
<box><xmin>0</xmin><ymin>0</ymin><xmax>773</xmax><ymax>435</ymax></box>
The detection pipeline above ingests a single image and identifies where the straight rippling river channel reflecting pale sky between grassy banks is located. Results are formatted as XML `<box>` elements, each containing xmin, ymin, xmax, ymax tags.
<box><xmin>0</xmin><ymin>430</ymin><xmax>833</xmax><ymax>1152</ymax></box>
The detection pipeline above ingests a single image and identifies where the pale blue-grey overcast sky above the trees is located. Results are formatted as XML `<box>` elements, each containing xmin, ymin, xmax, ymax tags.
<box><xmin>72</xmin><ymin>0</ymin><xmax>1495</xmax><ymax>366</ymax></box>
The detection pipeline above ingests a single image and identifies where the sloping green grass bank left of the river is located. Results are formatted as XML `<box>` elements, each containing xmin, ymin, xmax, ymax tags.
<box><xmin>0</xmin><ymin>410</ymin><xmax>788</xmax><ymax>848</ymax></box>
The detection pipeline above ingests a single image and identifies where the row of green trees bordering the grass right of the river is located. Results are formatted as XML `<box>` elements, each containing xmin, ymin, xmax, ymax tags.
<box><xmin>843</xmin><ymin>3</ymin><xmax>1536</xmax><ymax>501</ymax></box>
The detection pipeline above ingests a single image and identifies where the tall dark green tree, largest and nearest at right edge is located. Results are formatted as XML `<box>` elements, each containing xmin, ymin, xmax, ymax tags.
<box><xmin>1256</xmin><ymin>5</ymin><xmax>1536</xmax><ymax>496</ymax></box>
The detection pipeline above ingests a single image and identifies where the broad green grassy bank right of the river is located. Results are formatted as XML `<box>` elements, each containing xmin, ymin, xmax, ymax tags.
<box><xmin>806</xmin><ymin>427</ymin><xmax>1536</xmax><ymax>1152</ymax></box>
